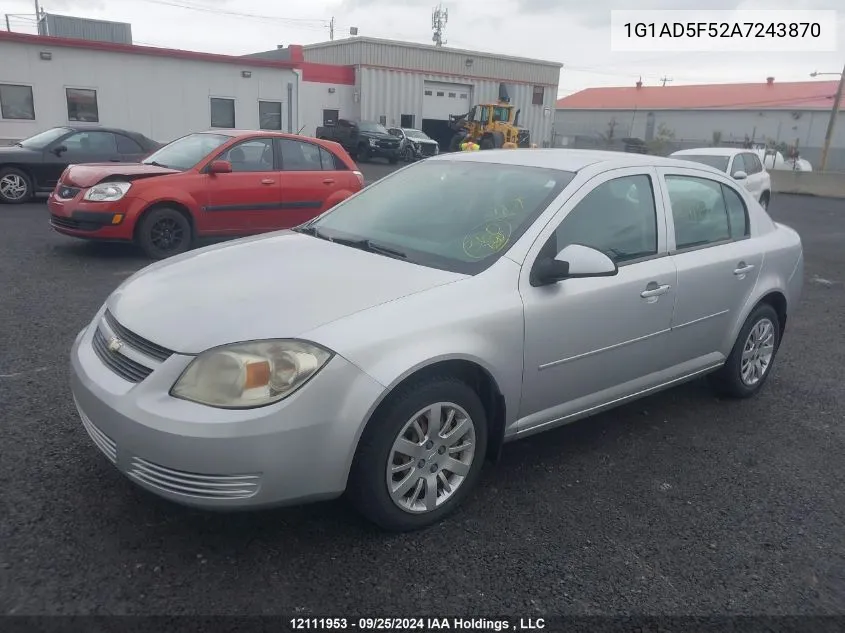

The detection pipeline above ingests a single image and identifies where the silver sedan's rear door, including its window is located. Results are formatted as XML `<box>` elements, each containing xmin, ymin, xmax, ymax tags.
<box><xmin>660</xmin><ymin>168</ymin><xmax>763</xmax><ymax>367</ymax></box>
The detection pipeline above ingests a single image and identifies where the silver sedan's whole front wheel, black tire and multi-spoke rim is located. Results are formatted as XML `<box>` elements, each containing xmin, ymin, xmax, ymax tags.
<box><xmin>346</xmin><ymin>376</ymin><xmax>487</xmax><ymax>532</ymax></box>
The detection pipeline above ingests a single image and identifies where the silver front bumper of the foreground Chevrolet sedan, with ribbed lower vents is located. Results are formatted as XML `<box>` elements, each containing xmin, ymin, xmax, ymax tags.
<box><xmin>71</xmin><ymin>315</ymin><xmax>384</xmax><ymax>509</ymax></box>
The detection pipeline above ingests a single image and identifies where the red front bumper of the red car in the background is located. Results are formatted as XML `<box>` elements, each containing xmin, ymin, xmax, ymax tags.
<box><xmin>47</xmin><ymin>191</ymin><xmax>145</xmax><ymax>240</ymax></box>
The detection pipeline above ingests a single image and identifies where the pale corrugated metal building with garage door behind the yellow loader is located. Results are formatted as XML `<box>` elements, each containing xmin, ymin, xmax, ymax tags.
<box><xmin>248</xmin><ymin>37</ymin><xmax>562</xmax><ymax>146</ymax></box>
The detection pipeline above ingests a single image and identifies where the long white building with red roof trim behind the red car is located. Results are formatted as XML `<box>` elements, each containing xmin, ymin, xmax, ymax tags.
<box><xmin>0</xmin><ymin>32</ymin><xmax>354</xmax><ymax>143</ymax></box>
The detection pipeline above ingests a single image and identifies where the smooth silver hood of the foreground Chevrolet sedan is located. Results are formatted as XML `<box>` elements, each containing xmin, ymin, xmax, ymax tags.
<box><xmin>106</xmin><ymin>231</ymin><xmax>465</xmax><ymax>354</ymax></box>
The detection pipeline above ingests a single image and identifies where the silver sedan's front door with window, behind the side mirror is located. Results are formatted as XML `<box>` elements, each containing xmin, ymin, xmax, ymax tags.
<box><xmin>519</xmin><ymin>168</ymin><xmax>677</xmax><ymax>431</ymax></box>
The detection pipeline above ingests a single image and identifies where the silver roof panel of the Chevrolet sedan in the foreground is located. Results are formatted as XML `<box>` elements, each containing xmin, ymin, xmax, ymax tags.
<box><xmin>426</xmin><ymin>148</ymin><xmax>721</xmax><ymax>174</ymax></box>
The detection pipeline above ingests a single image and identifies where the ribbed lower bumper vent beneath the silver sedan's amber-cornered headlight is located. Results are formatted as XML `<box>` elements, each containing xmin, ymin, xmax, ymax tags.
<box><xmin>129</xmin><ymin>457</ymin><xmax>261</xmax><ymax>499</ymax></box>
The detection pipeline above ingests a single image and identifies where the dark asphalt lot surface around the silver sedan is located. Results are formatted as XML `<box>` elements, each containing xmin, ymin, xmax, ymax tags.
<box><xmin>0</xmin><ymin>190</ymin><xmax>845</xmax><ymax>617</ymax></box>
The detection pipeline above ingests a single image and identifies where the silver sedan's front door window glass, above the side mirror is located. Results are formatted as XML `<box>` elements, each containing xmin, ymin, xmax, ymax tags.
<box><xmin>553</xmin><ymin>174</ymin><xmax>657</xmax><ymax>264</ymax></box>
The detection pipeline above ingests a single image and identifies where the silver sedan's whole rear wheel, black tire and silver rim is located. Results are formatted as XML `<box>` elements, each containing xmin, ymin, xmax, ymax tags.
<box><xmin>709</xmin><ymin>303</ymin><xmax>781</xmax><ymax>398</ymax></box>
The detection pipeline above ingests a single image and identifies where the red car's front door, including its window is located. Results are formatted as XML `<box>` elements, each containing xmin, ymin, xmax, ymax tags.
<box><xmin>202</xmin><ymin>138</ymin><xmax>282</xmax><ymax>235</ymax></box>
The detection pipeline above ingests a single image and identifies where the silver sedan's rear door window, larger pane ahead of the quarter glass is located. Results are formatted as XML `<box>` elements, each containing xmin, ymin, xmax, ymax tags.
<box><xmin>666</xmin><ymin>176</ymin><xmax>730</xmax><ymax>250</ymax></box>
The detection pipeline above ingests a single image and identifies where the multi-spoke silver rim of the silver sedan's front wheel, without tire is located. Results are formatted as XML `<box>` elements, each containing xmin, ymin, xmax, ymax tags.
<box><xmin>386</xmin><ymin>402</ymin><xmax>476</xmax><ymax>514</ymax></box>
